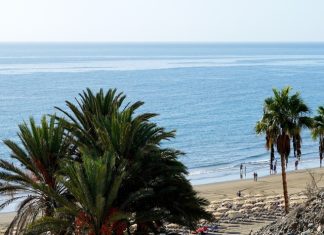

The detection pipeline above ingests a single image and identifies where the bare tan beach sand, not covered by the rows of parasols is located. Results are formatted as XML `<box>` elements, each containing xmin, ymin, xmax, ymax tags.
<box><xmin>0</xmin><ymin>168</ymin><xmax>324</xmax><ymax>234</ymax></box>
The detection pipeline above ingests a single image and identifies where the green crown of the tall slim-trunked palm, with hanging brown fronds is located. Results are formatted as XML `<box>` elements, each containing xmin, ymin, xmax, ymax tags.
<box><xmin>256</xmin><ymin>87</ymin><xmax>312</xmax><ymax>161</ymax></box>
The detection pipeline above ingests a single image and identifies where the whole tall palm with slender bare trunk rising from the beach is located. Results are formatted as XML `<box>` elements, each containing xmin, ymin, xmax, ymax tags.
<box><xmin>262</xmin><ymin>87</ymin><xmax>309</xmax><ymax>213</ymax></box>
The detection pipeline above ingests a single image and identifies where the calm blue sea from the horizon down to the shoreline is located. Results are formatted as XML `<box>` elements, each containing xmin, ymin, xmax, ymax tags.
<box><xmin>0</xmin><ymin>43</ymin><xmax>324</xmax><ymax>184</ymax></box>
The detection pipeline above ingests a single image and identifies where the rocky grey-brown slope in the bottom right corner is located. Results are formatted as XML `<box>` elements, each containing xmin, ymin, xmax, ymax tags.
<box><xmin>255</xmin><ymin>191</ymin><xmax>324</xmax><ymax>235</ymax></box>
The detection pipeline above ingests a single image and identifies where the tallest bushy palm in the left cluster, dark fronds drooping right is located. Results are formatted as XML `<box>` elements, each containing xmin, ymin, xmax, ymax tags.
<box><xmin>55</xmin><ymin>89</ymin><xmax>211</xmax><ymax>233</ymax></box>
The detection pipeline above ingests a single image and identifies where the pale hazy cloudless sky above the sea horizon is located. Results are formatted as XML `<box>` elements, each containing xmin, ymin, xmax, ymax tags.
<box><xmin>0</xmin><ymin>0</ymin><xmax>324</xmax><ymax>42</ymax></box>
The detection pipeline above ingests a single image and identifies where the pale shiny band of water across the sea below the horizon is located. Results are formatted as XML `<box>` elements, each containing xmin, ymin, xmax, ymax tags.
<box><xmin>0</xmin><ymin>56</ymin><xmax>324</xmax><ymax>74</ymax></box>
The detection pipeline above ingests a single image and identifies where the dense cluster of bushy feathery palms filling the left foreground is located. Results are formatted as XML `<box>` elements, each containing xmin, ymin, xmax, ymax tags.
<box><xmin>0</xmin><ymin>89</ymin><xmax>212</xmax><ymax>235</ymax></box>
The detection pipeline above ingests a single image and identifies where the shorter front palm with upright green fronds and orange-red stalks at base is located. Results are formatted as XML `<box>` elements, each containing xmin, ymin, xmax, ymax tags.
<box><xmin>27</xmin><ymin>152</ymin><xmax>130</xmax><ymax>235</ymax></box>
